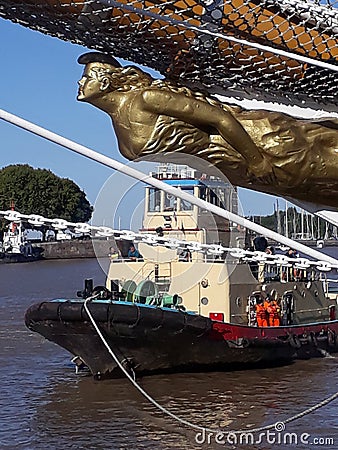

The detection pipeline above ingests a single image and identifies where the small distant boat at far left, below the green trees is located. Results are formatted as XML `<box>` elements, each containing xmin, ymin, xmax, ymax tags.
<box><xmin>0</xmin><ymin>221</ymin><xmax>43</xmax><ymax>263</ymax></box>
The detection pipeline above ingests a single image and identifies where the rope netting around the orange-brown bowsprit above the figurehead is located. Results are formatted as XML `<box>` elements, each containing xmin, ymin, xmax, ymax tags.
<box><xmin>0</xmin><ymin>0</ymin><xmax>338</xmax><ymax>110</ymax></box>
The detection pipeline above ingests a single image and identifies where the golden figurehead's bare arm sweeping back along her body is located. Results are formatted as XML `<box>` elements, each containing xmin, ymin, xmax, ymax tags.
<box><xmin>142</xmin><ymin>88</ymin><xmax>272</xmax><ymax>178</ymax></box>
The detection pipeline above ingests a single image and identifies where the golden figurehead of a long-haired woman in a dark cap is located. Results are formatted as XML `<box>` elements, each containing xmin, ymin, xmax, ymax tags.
<box><xmin>77</xmin><ymin>52</ymin><xmax>338</xmax><ymax>207</ymax></box>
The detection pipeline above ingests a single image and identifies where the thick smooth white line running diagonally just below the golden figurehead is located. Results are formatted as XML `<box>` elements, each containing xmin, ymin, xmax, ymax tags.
<box><xmin>0</xmin><ymin>109</ymin><xmax>338</xmax><ymax>267</ymax></box>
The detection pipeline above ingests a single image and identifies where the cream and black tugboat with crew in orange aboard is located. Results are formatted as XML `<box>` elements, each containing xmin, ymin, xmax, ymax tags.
<box><xmin>25</xmin><ymin>165</ymin><xmax>338</xmax><ymax>379</ymax></box>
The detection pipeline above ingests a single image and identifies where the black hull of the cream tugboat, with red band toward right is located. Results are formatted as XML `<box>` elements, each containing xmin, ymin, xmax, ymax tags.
<box><xmin>25</xmin><ymin>301</ymin><xmax>338</xmax><ymax>378</ymax></box>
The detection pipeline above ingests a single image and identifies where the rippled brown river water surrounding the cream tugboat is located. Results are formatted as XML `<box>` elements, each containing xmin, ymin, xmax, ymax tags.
<box><xmin>0</xmin><ymin>259</ymin><xmax>338</xmax><ymax>450</ymax></box>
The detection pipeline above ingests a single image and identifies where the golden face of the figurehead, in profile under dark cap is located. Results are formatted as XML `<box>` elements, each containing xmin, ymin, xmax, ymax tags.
<box><xmin>77</xmin><ymin>63</ymin><xmax>107</xmax><ymax>102</ymax></box>
